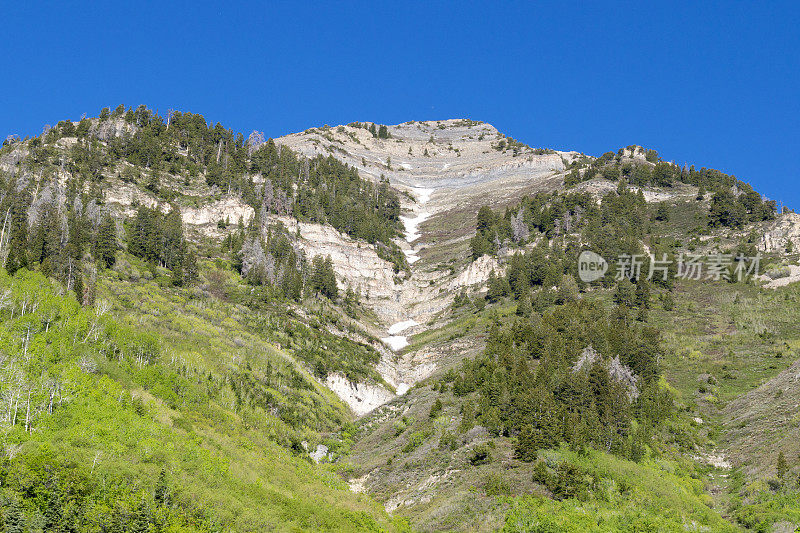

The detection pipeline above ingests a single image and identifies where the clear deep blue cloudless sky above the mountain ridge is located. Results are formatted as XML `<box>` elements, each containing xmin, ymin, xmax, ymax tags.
<box><xmin>0</xmin><ymin>1</ymin><xmax>800</xmax><ymax>208</ymax></box>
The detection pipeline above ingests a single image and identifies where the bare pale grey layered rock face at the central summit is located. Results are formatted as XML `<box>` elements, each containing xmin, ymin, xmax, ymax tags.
<box><xmin>275</xmin><ymin>119</ymin><xmax>568</xmax><ymax>198</ymax></box>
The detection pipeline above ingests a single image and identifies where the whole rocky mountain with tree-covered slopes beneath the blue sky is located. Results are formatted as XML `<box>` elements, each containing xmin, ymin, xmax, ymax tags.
<box><xmin>0</xmin><ymin>106</ymin><xmax>800</xmax><ymax>531</ymax></box>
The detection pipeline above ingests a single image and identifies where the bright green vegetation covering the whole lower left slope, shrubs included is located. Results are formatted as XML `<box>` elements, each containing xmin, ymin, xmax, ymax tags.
<box><xmin>0</xmin><ymin>269</ymin><xmax>404</xmax><ymax>531</ymax></box>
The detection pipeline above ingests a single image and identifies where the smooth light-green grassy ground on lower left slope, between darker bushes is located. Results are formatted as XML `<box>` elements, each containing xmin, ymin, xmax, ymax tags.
<box><xmin>0</xmin><ymin>271</ymin><xmax>402</xmax><ymax>531</ymax></box>
